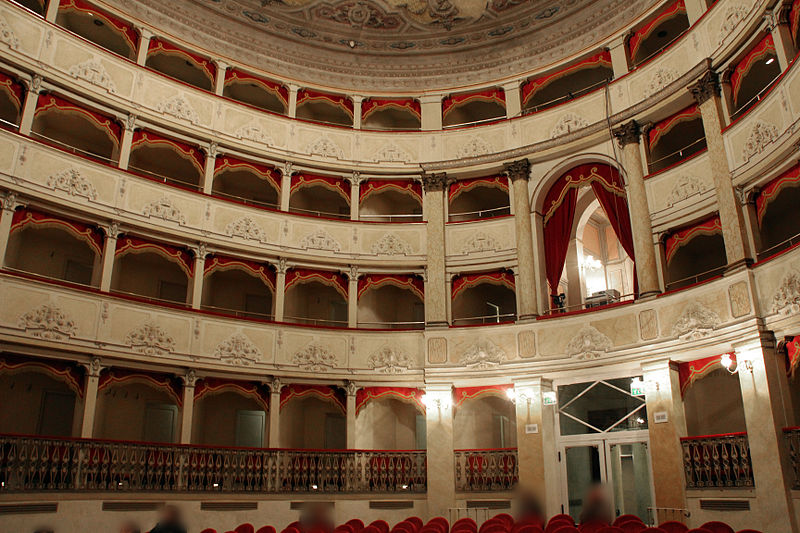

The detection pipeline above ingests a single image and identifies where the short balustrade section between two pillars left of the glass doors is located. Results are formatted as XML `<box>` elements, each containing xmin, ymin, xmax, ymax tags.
<box><xmin>453</xmin><ymin>448</ymin><xmax>519</xmax><ymax>492</ymax></box>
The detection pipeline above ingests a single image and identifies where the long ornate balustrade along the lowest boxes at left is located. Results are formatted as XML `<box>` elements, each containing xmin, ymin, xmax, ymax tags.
<box><xmin>0</xmin><ymin>435</ymin><xmax>427</xmax><ymax>494</ymax></box>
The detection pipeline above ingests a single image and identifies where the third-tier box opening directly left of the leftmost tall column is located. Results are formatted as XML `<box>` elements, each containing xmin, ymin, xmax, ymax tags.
<box><xmin>358</xmin><ymin>275</ymin><xmax>425</xmax><ymax>329</ymax></box>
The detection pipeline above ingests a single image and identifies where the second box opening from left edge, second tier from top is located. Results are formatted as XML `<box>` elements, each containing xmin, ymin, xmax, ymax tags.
<box><xmin>31</xmin><ymin>94</ymin><xmax>121</xmax><ymax>163</ymax></box>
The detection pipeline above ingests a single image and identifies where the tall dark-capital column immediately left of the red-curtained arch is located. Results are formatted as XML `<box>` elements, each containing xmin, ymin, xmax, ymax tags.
<box><xmin>503</xmin><ymin>159</ymin><xmax>539</xmax><ymax>320</ymax></box>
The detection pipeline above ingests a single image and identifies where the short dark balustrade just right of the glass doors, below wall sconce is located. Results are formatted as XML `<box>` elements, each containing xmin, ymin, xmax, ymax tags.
<box><xmin>681</xmin><ymin>433</ymin><xmax>755</xmax><ymax>489</ymax></box>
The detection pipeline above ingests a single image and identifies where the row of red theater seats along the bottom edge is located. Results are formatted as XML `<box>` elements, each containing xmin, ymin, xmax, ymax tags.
<box><xmin>201</xmin><ymin>514</ymin><xmax>761</xmax><ymax>533</ymax></box>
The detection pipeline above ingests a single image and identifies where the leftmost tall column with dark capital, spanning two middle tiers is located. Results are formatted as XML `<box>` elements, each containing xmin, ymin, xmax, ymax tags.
<box><xmin>422</xmin><ymin>173</ymin><xmax>450</xmax><ymax>327</ymax></box>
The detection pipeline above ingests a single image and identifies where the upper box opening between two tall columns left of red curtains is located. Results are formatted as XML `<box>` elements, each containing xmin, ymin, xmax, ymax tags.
<box><xmin>448</xmin><ymin>176</ymin><xmax>511</xmax><ymax>222</ymax></box>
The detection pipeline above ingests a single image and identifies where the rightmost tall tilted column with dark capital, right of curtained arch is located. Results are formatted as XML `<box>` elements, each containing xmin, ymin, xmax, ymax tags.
<box><xmin>689</xmin><ymin>70</ymin><xmax>752</xmax><ymax>269</ymax></box>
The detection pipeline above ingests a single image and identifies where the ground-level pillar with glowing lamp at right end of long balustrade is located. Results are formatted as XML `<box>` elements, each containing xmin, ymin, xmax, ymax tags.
<box><xmin>425</xmin><ymin>383</ymin><xmax>455</xmax><ymax>516</ymax></box>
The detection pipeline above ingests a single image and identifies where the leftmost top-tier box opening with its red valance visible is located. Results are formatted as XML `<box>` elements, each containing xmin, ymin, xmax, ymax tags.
<box><xmin>52</xmin><ymin>0</ymin><xmax>139</xmax><ymax>60</ymax></box>
